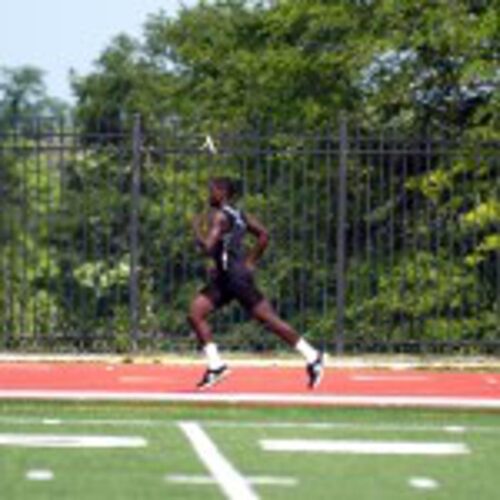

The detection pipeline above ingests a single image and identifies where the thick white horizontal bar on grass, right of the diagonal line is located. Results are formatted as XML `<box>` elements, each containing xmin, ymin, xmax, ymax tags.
<box><xmin>260</xmin><ymin>439</ymin><xmax>470</xmax><ymax>455</ymax></box>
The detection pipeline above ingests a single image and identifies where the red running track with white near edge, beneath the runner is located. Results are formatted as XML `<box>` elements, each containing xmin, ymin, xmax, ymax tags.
<box><xmin>0</xmin><ymin>362</ymin><xmax>500</xmax><ymax>410</ymax></box>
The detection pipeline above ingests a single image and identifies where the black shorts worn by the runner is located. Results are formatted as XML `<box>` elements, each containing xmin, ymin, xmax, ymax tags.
<box><xmin>201</xmin><ymin>269</ymin><xmax>264</xmax><ymax>312</ymax></box>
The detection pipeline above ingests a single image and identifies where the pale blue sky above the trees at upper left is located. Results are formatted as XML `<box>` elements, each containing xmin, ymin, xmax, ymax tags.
<box><xmin>0</xmin><ymin>0</ymin><xmax>197</xmax><ymax>103</ymax></box>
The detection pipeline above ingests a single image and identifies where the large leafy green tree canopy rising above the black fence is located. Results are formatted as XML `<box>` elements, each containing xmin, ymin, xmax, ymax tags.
<box><xmin>71</xmin><ymin>0</ymin><xmax>500</xmax><ymax>135</ymax></box>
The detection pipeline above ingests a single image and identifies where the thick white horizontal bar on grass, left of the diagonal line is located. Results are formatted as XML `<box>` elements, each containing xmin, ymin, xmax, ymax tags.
<box><xmin>0</xmin><ymin>434</ymin><xmax>147</xmax><ymax>448</ymax></box>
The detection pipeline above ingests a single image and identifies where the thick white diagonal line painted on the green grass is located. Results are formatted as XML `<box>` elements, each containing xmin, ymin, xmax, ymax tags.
<box><xmin>179</xmin><ymin>422</ymin><xmax>259</xmax><ymax>500</ymax></box>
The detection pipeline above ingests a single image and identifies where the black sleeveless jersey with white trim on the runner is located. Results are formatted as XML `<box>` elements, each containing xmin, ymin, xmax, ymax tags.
<box><xmin>214</xmin><ymin>205</ymin><xmax>247</xmax><ymax>272</ymax></box>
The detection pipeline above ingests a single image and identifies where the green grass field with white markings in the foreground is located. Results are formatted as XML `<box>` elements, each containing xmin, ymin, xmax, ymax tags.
<box><xmin>0</xmin><ymin>402</ymin><xmax>500</xmax><ymax>500</ymax></box>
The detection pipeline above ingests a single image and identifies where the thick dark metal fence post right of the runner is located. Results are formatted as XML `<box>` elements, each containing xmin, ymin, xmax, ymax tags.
<box><xmin>335</xmin><ymin>113</ymin><xmax>349</xmax><ymax>355</ymax></box>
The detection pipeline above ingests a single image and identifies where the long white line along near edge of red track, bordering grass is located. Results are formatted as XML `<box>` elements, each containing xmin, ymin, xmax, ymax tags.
<box><xmin>0</xmin><ymin>390</ymin><xmax>500</xmax><ymax>410</ymax></box>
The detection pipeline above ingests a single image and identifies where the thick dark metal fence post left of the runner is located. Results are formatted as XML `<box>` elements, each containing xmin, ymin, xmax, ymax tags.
<box><xmin>129</xmin><ymin>114</ymin><xmax>142</xmax><ymax>351</ymax></box>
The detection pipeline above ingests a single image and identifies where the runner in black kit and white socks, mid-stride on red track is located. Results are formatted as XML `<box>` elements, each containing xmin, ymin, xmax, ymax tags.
<box><xmin>188</xmin><ymin>177</ymin><xmax>323</xmax><ymax>389</ymax></box>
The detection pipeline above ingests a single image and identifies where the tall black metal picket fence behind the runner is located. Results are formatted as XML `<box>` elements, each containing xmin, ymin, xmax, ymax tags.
<box><xmin>0</xmin><ymin>117</ymin><xmax>500</xmax><ymax>352</ymax></box>
